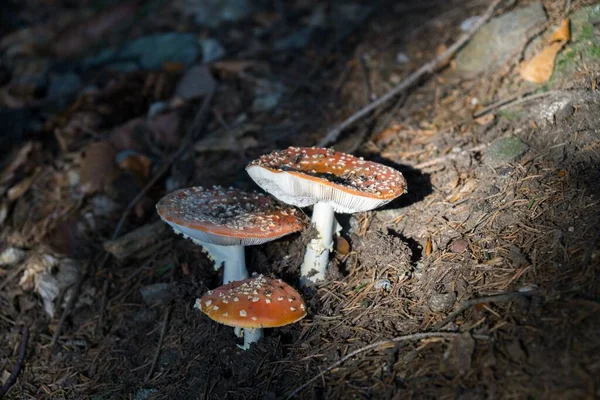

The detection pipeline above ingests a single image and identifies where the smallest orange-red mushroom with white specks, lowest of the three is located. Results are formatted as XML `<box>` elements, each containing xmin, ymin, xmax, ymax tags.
<box><xmin>194</xmin><ymin>275</ymin><xmax>306</xmax><ymax>350</ymax></box>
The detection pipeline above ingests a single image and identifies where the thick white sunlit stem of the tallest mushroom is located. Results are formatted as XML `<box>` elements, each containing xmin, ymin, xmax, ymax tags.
<box><xmin>300</xmin><ymin>202</ymin><xmax>339</xmax><ymax>285</ymax></box>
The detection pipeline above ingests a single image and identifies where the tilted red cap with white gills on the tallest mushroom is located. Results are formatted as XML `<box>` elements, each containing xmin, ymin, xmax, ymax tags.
<box><xmin>246</xmin><ymin>147</ymin><xmax>406</xmax><ymax>212</ymax></box>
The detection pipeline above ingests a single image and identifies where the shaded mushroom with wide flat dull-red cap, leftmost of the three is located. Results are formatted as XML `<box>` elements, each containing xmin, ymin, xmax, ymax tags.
<box><xmin>156</xmin><ymin>186</ymin><xmax>307</xmax><ymax>284</ymax></box>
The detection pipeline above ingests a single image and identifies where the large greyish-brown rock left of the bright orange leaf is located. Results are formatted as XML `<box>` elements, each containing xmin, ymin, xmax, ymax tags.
<box><xmin>456</xmin><ymin>3</ymin><xmax>546</xmax><ymax>73</ymax></box>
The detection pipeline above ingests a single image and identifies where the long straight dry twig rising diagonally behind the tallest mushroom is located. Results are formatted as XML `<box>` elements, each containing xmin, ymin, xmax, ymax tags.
<box><xmin>317</xmin><ymin>0</ymin><xmax>502</xmax><ymax>147</ymax></box>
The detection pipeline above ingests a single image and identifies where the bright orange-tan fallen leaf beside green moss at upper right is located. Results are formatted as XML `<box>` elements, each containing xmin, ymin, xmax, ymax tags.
<box><xmin>521</xmin><ymin>19</ymin><xmax>571</xmax><ymax>83</ymax></box>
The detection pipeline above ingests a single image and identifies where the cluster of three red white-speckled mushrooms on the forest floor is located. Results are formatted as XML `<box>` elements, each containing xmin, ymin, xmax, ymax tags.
<box><xmin>156</xmin><ymin>147</ymin><xmax>406</xmax><ymax>349</ymax></box>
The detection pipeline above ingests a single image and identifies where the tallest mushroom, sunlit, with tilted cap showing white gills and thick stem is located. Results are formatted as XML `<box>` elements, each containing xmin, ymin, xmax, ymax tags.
<box><xmin>246</xmin><ymin>147</ymin><xmax>406</xmax><ymax>284</ymax></box>
